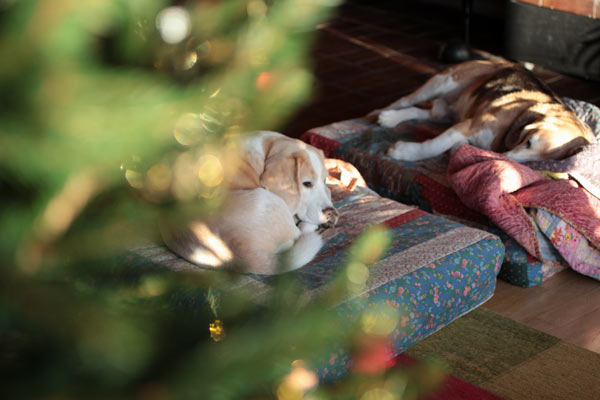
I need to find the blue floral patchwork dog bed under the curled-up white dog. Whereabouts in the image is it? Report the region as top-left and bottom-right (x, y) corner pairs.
(129, 176), (504, 380)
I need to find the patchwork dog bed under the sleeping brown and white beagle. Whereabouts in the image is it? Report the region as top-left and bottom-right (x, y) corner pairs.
(302, 99), (600, 287)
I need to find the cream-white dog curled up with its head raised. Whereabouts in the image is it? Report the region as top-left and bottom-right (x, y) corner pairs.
(161, 131), (337, 274)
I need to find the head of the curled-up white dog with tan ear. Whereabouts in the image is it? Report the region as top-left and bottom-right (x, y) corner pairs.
(260, 135), (338, 227)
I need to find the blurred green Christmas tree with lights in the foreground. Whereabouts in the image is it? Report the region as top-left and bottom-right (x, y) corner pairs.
(0, 0), (439, 399)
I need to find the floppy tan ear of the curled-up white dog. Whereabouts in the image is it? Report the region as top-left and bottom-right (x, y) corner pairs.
(260, 151), (310, 213)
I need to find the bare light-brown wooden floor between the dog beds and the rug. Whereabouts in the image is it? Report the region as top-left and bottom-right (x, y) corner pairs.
(483, 270), (600, 353)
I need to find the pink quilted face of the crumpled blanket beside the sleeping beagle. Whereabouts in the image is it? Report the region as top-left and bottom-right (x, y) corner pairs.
(448, 145), (600, 259)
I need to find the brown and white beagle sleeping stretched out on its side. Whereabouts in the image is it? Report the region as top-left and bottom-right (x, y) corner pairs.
(379, 60), (596, 162)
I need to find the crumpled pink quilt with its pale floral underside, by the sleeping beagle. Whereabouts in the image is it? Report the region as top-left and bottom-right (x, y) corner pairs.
(448, 145), (600, 277)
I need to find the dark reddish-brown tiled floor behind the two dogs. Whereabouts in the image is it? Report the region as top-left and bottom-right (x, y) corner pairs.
(282, 0), (600, 137)
